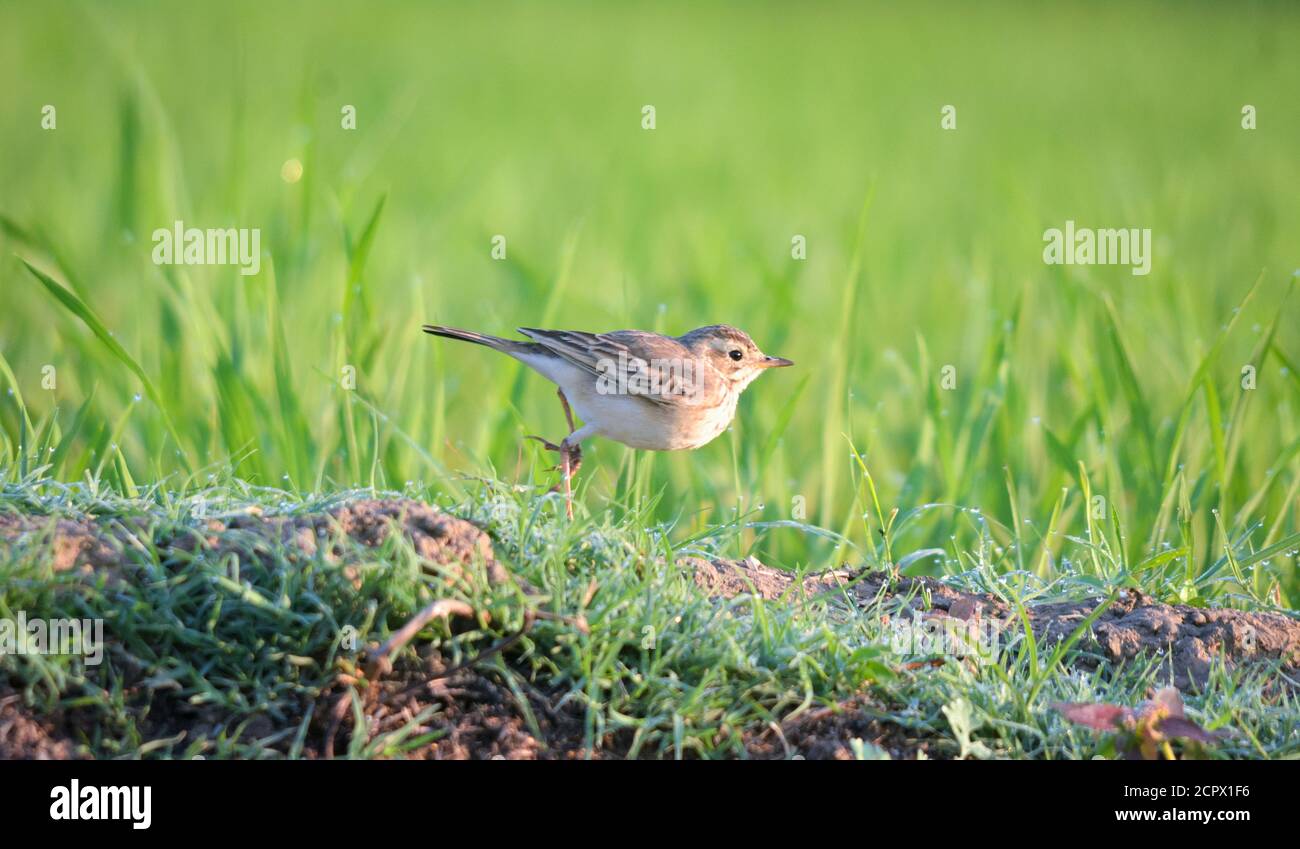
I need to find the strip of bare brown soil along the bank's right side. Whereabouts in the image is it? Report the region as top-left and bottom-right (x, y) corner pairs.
(681, 558), (1300, 690)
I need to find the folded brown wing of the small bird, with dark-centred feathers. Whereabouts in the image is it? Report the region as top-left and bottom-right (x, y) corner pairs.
(519, 328), (720, 406)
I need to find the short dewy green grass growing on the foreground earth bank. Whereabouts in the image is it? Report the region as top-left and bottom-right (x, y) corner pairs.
(0, 470), (1300, 758)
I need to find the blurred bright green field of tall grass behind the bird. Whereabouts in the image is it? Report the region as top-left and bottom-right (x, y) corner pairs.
(0, 1), (1300, 595)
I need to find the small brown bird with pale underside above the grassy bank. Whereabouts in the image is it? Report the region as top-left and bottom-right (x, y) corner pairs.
(423, 324), (794, 519)
